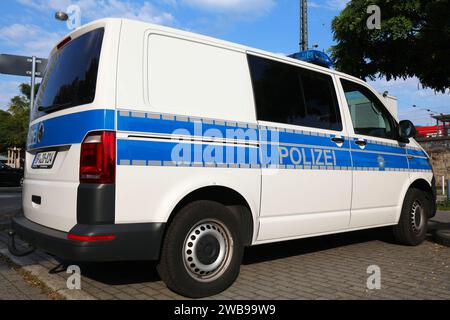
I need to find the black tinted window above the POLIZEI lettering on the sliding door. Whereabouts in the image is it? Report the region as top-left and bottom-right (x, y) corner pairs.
(248, 56), (342, 130)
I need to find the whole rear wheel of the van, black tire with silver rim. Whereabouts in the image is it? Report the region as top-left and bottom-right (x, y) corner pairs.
(157, 200), (244, 298)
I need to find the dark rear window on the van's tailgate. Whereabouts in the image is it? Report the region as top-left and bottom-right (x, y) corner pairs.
(31, 28), (104, 120)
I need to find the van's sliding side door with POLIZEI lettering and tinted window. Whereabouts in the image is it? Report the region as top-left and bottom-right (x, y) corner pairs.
(249, 55), (352, 241)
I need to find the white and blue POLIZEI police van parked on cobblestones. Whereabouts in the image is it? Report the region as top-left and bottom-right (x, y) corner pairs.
(12, 19), (436, 297)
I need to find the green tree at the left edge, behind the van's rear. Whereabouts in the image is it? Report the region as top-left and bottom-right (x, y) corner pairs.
(0, 83), (39, 152)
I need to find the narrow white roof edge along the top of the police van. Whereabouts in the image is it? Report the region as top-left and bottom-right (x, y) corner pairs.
(57, 18), (366, 83)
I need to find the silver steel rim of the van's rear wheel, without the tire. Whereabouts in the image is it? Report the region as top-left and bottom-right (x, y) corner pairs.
(183, 220), (233, 282)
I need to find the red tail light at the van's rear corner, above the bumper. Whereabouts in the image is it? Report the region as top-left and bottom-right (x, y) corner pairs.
(80, 131), (116, 184)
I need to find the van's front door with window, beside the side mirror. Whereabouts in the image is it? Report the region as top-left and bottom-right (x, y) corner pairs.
(340, 79), (409, 228)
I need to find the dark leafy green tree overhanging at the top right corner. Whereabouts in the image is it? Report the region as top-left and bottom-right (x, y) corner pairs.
(331, 0), (450, 92)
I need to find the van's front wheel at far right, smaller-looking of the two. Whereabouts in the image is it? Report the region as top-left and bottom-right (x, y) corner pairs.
(393, 188), (431, 246)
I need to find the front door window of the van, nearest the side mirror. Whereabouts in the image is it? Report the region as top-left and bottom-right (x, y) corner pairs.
(341, 79), (398, 139)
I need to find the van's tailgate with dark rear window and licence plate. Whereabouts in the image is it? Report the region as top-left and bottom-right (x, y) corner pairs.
(23, 26), (114, 231)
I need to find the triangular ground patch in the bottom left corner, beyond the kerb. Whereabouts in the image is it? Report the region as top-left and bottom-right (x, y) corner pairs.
(0, 257), (49, 300)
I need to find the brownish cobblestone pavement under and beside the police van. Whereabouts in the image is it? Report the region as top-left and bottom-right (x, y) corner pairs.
(0, 212), (450, 299)
